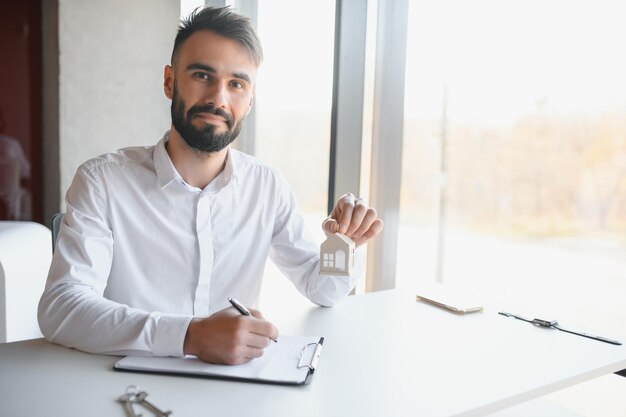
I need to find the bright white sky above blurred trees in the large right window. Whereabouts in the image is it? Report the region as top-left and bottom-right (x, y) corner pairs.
(406, 0), (626, 123)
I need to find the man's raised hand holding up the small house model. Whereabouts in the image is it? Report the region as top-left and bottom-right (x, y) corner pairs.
(322, 193), (383, 246)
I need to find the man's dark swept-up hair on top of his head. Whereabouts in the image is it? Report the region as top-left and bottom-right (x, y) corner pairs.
(172, 6), (263, 67)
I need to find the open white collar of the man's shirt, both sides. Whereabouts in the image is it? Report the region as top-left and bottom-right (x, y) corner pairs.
(154, 130), (241, 192)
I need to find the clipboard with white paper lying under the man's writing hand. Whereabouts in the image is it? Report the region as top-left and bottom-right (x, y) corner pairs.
(113, 336), (324, 385)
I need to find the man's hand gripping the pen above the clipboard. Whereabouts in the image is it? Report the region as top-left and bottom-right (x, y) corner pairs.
(183, 307), (278, 365)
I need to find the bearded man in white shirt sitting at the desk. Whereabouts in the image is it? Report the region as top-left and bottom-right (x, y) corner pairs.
(39, 8), (383, 364)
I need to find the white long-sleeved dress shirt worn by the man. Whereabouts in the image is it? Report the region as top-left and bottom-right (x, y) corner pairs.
(39, 133), (364, 356)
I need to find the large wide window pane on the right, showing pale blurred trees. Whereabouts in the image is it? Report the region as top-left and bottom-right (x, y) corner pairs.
(398, 0), (626, 318)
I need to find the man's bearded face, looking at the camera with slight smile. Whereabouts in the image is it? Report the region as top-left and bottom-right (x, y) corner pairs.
(165, 31), (256, 152)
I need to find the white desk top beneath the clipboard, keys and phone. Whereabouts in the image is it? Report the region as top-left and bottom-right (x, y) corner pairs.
(0, 291), (626, 417)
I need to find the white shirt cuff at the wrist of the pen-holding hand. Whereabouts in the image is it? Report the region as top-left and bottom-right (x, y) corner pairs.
(152, 314), (192, 357)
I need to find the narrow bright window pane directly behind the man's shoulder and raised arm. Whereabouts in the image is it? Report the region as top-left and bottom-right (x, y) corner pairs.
(255, 0), (335, 302)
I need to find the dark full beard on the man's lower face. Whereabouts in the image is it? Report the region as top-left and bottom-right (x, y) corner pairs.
(171, 84), (244, 153)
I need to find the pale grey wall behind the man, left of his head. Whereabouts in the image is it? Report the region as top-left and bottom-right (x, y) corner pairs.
(58, 0), (180, 205)
